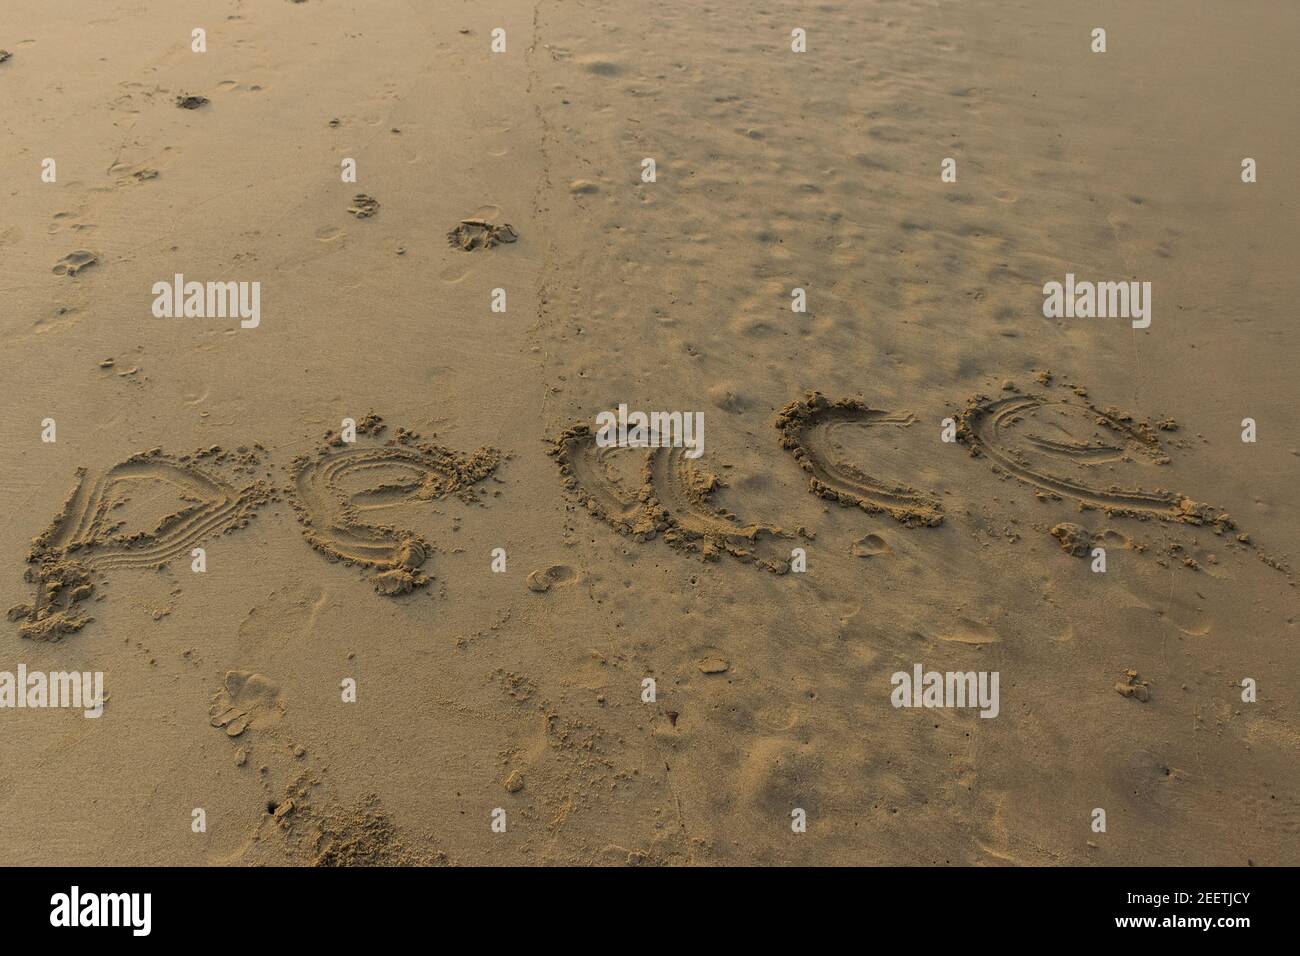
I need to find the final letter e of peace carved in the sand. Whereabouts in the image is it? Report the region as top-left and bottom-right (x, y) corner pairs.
(957, 389), (1232, 531)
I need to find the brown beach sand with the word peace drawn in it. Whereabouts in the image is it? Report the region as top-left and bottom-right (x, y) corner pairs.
(0, 0), (1300, 865)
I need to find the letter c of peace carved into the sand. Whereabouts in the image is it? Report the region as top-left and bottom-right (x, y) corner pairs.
(776, 392), (944, 527)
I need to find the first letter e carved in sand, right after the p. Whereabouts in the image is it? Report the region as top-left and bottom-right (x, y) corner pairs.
(293, 415), (501, 596)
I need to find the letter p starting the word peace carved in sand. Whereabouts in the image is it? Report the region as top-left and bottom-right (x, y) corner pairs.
(9, 446), (272, 640)
